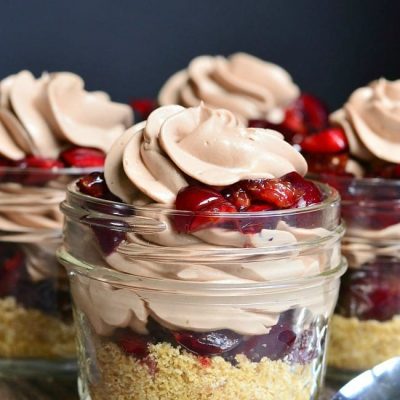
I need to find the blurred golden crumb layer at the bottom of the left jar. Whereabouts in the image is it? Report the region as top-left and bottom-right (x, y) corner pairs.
(0, 297), (76, 359)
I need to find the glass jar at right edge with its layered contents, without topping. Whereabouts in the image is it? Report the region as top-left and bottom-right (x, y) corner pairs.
(314, 176), (400, 379)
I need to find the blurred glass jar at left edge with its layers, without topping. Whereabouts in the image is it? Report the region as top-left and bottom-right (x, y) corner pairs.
(0, 167), (98, 375)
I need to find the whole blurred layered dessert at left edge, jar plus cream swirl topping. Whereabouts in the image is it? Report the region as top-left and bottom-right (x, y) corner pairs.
(0, 71), (132, 373)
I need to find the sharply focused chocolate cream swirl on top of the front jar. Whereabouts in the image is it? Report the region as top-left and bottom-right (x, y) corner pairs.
(105, 104), (307, 204)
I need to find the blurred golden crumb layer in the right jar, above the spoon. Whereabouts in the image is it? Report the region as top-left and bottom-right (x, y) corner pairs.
(328, 315), (400, 371)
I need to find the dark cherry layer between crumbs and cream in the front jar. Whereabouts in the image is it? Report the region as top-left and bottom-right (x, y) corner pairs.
(113, 310), (324, 367)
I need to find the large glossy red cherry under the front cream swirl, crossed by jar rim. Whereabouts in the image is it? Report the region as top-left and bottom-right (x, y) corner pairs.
(174, 186), (237, 232)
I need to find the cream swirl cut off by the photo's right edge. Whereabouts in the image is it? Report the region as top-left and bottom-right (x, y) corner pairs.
(330, 78), (400, 163)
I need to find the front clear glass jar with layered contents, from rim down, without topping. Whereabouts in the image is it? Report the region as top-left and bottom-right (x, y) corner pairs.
(58, 185), (346, 400)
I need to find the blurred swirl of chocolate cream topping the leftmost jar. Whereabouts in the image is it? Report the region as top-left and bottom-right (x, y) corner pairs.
(0, 71), (133, 160)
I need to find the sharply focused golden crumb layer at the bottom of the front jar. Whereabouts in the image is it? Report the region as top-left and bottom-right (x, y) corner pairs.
(89, 342), (314, 400)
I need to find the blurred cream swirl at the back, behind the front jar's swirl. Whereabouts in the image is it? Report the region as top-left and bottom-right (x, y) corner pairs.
(158, 53), (300, 123)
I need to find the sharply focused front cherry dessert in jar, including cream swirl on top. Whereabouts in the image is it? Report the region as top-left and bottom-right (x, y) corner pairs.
(58, 105), (345, 400)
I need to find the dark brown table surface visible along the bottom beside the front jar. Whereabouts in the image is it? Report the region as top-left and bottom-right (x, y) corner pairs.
(0, 377), (334, 400)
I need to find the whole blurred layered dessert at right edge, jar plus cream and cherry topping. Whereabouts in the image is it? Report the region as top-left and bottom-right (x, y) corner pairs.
(284, 78), (400, 377)
